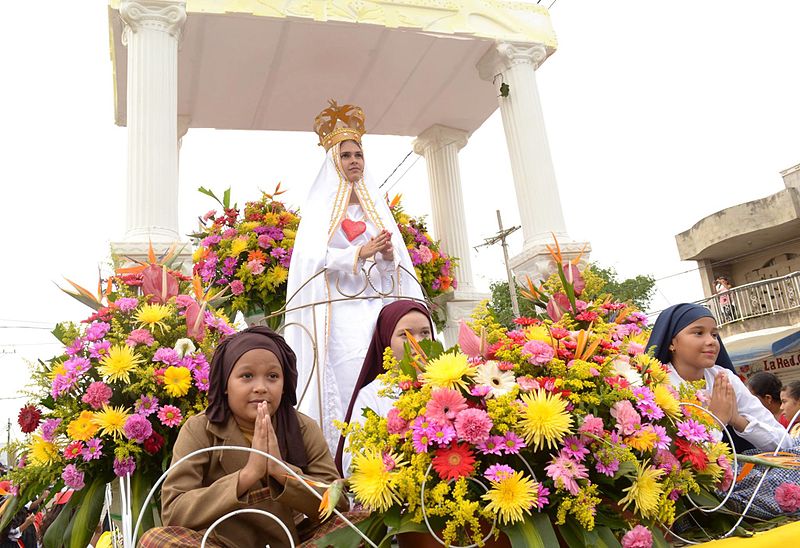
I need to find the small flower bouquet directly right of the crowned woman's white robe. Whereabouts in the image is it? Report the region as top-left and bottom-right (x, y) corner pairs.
(389, 195), (458, 329)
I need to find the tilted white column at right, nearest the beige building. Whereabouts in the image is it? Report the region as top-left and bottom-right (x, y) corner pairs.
(478, 42), (589, 278)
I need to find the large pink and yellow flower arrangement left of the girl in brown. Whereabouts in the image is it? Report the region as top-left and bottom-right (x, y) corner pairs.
(0, 249), (233, 546)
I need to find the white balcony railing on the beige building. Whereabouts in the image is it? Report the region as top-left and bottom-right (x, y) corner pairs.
(697, 272), (800, 326)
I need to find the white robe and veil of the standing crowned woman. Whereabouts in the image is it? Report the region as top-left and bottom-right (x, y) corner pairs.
(284, 144), (423, 452)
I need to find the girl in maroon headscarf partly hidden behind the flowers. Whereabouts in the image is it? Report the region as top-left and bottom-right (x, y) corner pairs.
(336, 299), (434, 473)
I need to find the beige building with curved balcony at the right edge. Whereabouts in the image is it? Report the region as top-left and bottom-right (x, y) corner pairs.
(675, 164), (800, 382)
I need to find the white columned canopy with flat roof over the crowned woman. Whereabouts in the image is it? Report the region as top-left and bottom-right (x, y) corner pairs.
(109, 0), (584, 338)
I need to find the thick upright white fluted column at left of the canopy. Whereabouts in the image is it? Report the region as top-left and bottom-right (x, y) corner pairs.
(119, 0), (186, 243)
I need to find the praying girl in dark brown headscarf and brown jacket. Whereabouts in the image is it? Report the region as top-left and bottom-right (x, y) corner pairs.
(139, 327), (339, 548)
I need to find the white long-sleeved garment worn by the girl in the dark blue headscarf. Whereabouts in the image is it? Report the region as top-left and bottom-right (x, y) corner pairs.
(667, 364), (792, 451)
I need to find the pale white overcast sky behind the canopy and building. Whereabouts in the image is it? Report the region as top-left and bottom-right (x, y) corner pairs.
(0, 0), (800, 438)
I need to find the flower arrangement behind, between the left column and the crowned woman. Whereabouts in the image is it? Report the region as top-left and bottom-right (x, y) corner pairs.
(193, 185), (300, 327)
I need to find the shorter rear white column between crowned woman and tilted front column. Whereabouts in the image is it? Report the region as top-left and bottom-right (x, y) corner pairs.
(413, 125), (475, 292)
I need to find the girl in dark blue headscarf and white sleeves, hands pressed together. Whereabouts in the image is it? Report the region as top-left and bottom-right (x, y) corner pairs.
(647, 303), (788, 452)
